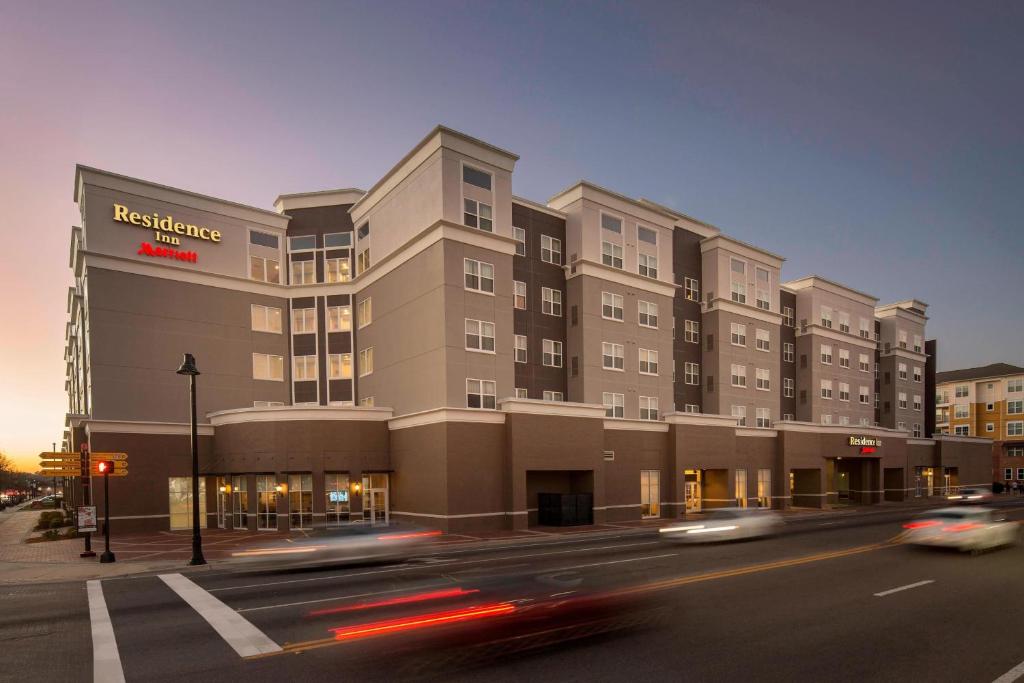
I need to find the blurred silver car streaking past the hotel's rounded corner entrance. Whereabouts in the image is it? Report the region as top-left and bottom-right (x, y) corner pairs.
(231, 524), (441, 566)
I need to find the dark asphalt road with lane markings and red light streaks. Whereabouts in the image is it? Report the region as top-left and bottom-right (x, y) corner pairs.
(6, 500), (1024, 682)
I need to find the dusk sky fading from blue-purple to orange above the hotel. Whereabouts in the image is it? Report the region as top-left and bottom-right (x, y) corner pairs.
(0, 0), (1024, 468)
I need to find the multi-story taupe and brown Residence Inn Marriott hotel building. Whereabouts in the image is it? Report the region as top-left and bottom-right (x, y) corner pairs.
(65, 127), (990, 531)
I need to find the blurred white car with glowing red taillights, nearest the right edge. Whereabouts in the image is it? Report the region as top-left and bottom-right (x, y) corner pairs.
(903, 508), (1020, 552)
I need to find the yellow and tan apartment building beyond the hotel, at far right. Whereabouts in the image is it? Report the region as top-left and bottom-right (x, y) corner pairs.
(935, 362), (1024, 483)
